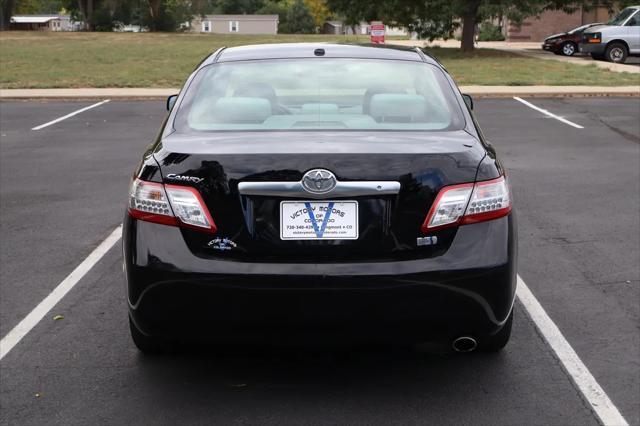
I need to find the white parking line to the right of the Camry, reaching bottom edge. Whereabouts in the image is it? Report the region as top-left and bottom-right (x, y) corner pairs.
(516, 275), (629, 426)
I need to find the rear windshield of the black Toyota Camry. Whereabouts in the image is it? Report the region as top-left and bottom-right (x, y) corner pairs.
(175, 58), (464, 131)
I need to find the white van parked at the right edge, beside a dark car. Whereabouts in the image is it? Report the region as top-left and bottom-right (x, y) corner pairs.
(580, 6), (640, 63)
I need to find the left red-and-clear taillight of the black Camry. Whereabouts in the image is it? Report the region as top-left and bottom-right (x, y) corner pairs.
(129, 179), (217, 233)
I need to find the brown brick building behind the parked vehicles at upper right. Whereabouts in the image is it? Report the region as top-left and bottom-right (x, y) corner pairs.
(505, 7), (611, 42)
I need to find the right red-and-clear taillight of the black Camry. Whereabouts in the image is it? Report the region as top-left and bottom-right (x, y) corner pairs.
(422, 176), (511, 233)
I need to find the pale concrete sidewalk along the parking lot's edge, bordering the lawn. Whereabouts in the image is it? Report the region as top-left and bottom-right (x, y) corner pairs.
(0, 85), (640, 99)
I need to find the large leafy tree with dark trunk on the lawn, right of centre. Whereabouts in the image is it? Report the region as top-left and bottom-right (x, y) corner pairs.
(328, 0), (616, 52)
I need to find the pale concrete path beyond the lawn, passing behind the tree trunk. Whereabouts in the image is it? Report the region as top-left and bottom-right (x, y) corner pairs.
(387, 40), (640, 74)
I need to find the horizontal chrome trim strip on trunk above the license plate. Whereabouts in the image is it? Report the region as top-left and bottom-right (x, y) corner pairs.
(238, 181), (400, 199)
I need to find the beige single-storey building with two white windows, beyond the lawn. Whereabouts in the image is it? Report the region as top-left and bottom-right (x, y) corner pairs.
(191, 15), (278, 34)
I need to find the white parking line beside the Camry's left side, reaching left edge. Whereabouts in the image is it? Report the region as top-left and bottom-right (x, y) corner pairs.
(0, 225), (122, 360)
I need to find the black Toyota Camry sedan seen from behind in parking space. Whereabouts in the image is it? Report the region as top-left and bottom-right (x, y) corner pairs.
(123, 44), (516, 352)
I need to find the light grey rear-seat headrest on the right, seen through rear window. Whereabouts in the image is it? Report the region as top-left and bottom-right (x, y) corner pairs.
(369, 93), (427, 123)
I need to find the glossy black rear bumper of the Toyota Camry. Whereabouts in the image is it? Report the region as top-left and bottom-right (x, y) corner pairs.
(123, 215), (516, 341)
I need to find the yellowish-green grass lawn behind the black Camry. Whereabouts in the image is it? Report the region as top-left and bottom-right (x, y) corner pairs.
(0, 32), (640, 89)
